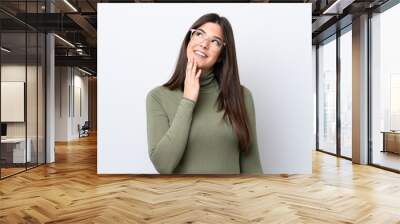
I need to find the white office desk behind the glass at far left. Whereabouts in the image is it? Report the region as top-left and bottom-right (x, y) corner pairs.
(1, 138), (32, 163)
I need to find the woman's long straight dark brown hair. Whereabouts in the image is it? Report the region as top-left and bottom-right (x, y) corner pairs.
(163, 13), (250, 152)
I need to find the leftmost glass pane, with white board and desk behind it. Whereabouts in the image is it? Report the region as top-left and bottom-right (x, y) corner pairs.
(0, 32), (27, 177)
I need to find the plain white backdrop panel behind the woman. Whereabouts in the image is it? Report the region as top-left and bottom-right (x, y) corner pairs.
(97, 3), (314, 174)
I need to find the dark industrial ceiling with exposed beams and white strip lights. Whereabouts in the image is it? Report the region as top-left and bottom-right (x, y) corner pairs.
(0, 0), (394, 73)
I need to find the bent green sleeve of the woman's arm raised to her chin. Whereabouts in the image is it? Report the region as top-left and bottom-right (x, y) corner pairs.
(146, 91), (195, 174)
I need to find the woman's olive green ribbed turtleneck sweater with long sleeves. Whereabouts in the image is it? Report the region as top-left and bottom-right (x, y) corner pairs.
(146, 72), (262, 174)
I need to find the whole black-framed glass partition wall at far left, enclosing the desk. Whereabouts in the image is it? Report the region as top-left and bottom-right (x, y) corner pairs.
(0, 1), (46, 179)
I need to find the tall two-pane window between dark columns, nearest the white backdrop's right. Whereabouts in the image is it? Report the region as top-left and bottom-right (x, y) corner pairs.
(316, 25), (352, 159)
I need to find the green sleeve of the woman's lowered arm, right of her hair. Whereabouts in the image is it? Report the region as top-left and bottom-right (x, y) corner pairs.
(240, 88), (263, 174)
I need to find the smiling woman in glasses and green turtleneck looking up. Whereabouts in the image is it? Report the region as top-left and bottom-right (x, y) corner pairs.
(146, 13), (262, 174)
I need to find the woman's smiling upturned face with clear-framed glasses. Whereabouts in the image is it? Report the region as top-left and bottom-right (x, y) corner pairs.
(186, 22), (224, 72)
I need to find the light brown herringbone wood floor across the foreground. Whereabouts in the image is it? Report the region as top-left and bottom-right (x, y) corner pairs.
(0, 134), (400, 224)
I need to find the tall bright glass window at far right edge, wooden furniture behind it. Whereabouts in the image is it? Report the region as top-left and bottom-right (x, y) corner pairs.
(370, 4), (400, 171)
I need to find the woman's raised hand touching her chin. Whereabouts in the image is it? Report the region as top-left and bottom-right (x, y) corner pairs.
(183, 58), (201, 102)
